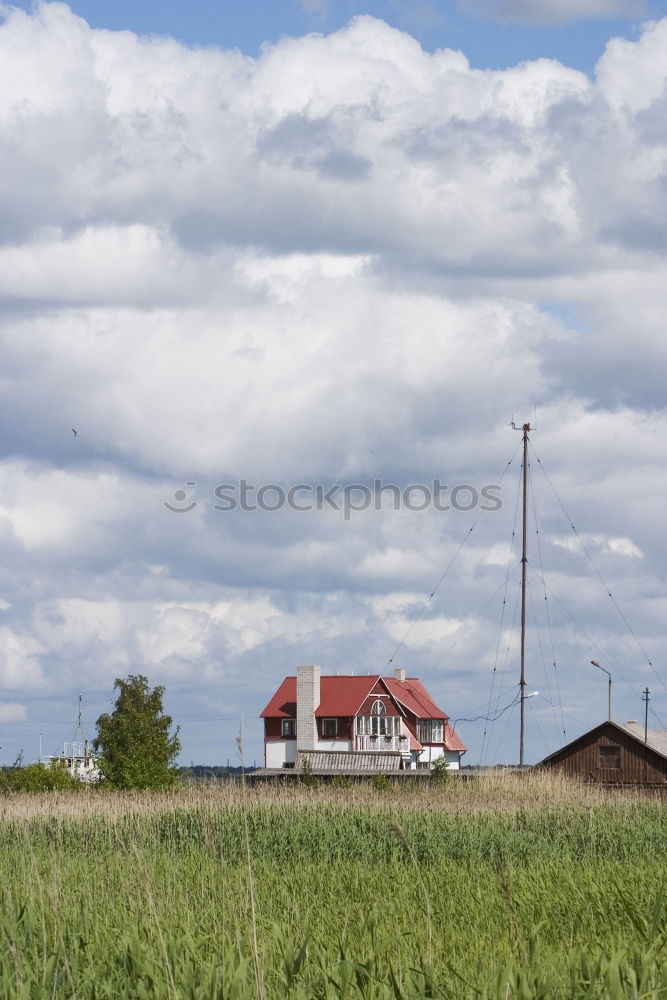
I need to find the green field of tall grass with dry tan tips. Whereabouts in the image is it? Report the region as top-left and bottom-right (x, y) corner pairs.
(0, 775), (667, 1000)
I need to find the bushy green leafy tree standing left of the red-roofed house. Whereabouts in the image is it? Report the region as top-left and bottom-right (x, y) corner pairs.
(94, 674), (181, 788)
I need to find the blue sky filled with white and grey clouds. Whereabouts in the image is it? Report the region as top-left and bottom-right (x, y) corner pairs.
(0, 0), (667, 764)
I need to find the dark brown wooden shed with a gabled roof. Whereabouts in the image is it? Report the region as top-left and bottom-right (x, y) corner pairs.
(536, 722), (667, 785)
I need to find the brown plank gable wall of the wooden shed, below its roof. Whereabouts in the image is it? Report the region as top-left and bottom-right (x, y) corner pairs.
(542, 724), (667, 784)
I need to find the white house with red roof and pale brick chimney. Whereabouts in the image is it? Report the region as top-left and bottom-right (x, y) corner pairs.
(261, 665), (466, 774)
